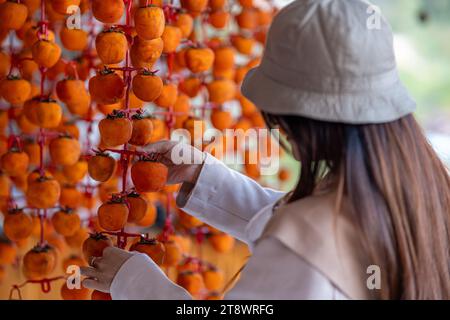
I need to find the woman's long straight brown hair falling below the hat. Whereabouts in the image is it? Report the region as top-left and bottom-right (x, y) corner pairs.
(264, 114), (450, 299)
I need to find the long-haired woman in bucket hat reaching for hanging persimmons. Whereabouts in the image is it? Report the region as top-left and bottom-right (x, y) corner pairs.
(83, 0), (450, 299)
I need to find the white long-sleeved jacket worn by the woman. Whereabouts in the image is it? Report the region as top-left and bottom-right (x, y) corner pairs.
(111, 156), (365, 299)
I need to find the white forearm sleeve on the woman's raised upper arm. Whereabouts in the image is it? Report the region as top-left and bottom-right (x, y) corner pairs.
(177, 155), (284, 242)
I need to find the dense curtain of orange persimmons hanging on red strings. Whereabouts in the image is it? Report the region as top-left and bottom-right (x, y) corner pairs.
(0, 0), (287, 299)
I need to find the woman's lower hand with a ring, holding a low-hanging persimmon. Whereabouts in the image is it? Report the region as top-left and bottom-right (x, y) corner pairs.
(81, 247), (133, 293)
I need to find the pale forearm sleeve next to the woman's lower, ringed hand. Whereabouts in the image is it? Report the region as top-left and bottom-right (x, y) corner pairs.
(110, 253), (192, 300)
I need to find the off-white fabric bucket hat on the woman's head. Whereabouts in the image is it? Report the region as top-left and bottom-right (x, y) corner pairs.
(242, 0), (416, 124)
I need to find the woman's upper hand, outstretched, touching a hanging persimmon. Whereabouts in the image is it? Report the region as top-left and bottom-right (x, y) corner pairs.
(145, 140), (204, 184)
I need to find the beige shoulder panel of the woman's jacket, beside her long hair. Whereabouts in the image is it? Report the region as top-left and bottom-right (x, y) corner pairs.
(258, 192), (369, 299)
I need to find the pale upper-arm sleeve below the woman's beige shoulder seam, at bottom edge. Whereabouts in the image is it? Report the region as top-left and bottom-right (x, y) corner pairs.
(225, 238), (347, 300)
